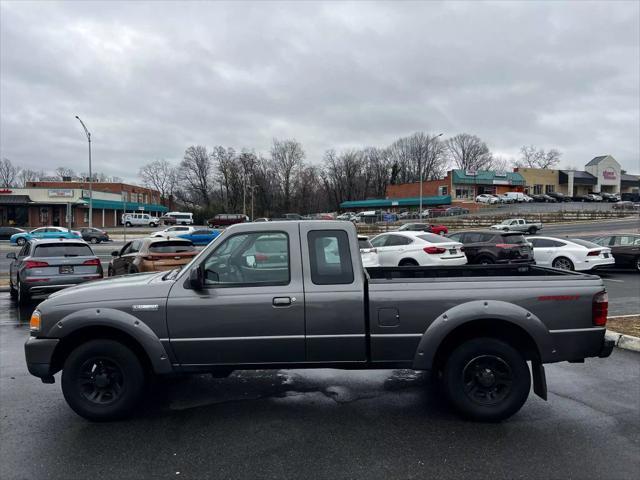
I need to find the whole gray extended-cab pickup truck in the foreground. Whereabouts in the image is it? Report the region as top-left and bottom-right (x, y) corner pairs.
(25, 221), (613, 421)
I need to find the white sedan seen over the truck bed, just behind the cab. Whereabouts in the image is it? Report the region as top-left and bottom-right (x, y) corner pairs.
(371, 231), (467, 267)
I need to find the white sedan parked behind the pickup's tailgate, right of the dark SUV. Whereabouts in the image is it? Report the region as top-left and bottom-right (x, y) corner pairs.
(527, 237), (615, 272)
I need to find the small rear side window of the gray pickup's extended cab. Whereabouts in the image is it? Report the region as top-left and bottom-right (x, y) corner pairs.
(307, 230), (354, 285)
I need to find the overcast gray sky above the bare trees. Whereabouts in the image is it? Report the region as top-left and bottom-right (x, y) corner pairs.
(0, 0), (640, 179)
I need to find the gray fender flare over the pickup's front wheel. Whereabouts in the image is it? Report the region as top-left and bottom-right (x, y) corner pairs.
(47, 307), (173, 374)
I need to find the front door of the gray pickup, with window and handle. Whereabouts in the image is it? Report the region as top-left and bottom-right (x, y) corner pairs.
(167, 223), (305, 366)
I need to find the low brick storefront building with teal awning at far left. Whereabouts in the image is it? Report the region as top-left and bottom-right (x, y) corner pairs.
(0, 182), (168, 228)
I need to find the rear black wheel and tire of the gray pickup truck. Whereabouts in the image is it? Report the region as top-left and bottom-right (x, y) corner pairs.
(443, 338), (531, 422)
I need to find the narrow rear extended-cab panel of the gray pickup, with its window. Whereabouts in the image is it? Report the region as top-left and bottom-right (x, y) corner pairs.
(300, 222), (367, 363)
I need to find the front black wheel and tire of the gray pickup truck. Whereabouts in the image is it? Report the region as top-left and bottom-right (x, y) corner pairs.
(62, 340), (145, 421)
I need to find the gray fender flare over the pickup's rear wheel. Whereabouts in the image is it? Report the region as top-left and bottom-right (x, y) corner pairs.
(413, 300), (551, 370)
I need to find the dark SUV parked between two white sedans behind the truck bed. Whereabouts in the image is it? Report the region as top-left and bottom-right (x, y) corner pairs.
(448, 230), (535, 265)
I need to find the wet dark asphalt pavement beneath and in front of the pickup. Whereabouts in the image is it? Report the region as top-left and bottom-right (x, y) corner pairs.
(0, 295), (640, 480)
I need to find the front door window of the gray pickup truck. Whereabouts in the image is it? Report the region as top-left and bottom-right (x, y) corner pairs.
(203, 232), (290, 287)
